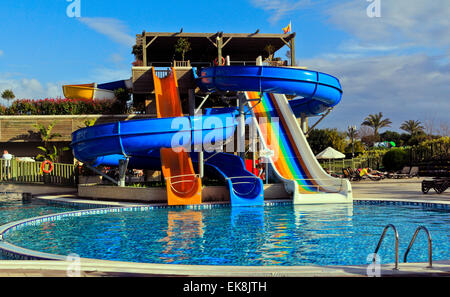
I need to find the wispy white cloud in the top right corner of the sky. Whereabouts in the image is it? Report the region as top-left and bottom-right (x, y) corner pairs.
(326, 0), (450, 47)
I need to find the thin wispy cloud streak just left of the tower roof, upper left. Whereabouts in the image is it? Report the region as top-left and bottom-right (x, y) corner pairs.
(78, 17), (136, 47)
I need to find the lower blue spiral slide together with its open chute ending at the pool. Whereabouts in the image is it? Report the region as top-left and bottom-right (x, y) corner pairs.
(71, 109), (264, 206)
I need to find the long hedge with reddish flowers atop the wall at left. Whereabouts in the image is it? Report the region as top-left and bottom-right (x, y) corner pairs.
(0, 98), (123, 115)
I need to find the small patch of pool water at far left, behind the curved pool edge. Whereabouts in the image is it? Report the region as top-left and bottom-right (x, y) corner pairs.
(0, 200), (79, 260)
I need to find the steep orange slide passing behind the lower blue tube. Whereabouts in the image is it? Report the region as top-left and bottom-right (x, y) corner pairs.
(152, 68), (202, 205)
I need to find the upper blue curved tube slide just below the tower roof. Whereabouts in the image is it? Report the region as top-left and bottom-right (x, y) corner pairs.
(194, 66), (342, 117)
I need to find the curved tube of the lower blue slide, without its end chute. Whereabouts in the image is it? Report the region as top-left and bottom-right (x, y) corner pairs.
(71, 113), (236, 165)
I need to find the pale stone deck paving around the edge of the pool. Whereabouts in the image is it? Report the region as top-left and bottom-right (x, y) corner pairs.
(0, 178), (450, 277)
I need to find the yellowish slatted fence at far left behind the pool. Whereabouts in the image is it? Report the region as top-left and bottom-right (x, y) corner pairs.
(0, 159), (77, 185)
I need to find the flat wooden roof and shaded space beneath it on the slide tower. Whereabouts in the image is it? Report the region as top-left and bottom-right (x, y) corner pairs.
(137, 32), (295, 66)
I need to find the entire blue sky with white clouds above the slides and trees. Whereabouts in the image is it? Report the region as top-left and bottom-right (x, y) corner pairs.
(0, 0), (450, 134)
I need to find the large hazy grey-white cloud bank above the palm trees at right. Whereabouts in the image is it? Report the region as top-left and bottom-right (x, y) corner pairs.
(302, 54), (450, 130)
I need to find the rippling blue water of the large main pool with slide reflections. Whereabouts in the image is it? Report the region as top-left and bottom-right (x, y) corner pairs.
(2, 204), (450, 266)
